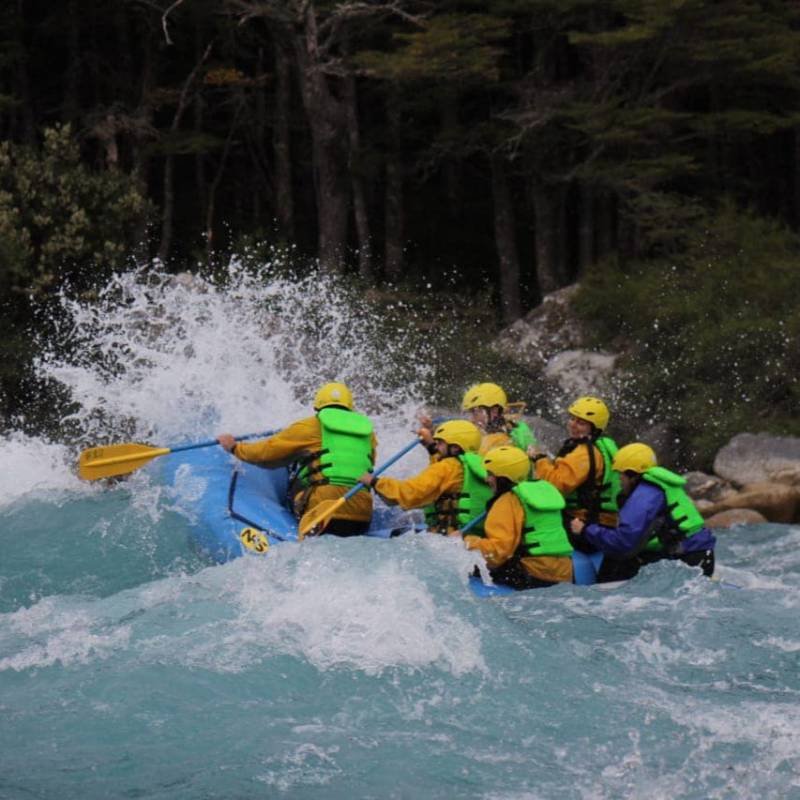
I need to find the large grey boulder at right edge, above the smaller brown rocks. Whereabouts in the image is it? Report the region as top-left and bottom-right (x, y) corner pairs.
(714, 433), (800, 486)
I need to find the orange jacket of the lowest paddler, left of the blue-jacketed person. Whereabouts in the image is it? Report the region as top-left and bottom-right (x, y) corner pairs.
(464, 492), (572, 583)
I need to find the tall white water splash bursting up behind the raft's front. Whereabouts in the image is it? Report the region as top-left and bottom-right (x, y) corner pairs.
(35, 259), (438, 454)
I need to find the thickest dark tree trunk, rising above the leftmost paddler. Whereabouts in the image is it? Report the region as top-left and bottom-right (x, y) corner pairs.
(295, 3), (350, 270)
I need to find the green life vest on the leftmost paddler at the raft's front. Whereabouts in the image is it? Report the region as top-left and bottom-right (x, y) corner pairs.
(299, 407), (373, 486)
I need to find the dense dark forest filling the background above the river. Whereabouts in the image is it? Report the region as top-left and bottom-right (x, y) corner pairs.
(0, 0), (800, 460)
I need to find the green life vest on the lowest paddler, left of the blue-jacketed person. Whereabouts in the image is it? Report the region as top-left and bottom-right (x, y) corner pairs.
(511, 481), (572, 558)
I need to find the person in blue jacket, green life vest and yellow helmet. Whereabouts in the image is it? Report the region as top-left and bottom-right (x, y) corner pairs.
(570, 442), (716, 577)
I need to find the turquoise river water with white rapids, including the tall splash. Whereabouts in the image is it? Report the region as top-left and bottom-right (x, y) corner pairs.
(0, 262), (800, 800)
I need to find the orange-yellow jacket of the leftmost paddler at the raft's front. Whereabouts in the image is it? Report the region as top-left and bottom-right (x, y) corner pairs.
(233, 416), (378, 522)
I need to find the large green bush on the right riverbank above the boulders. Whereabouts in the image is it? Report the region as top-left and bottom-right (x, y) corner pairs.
(577, 203), (800, 465)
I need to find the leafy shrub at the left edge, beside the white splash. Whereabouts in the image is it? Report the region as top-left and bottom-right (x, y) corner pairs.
(0, 125), (152, 427)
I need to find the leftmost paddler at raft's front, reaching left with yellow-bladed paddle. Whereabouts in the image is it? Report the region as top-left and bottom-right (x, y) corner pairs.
(217, 382), (377, 536)
